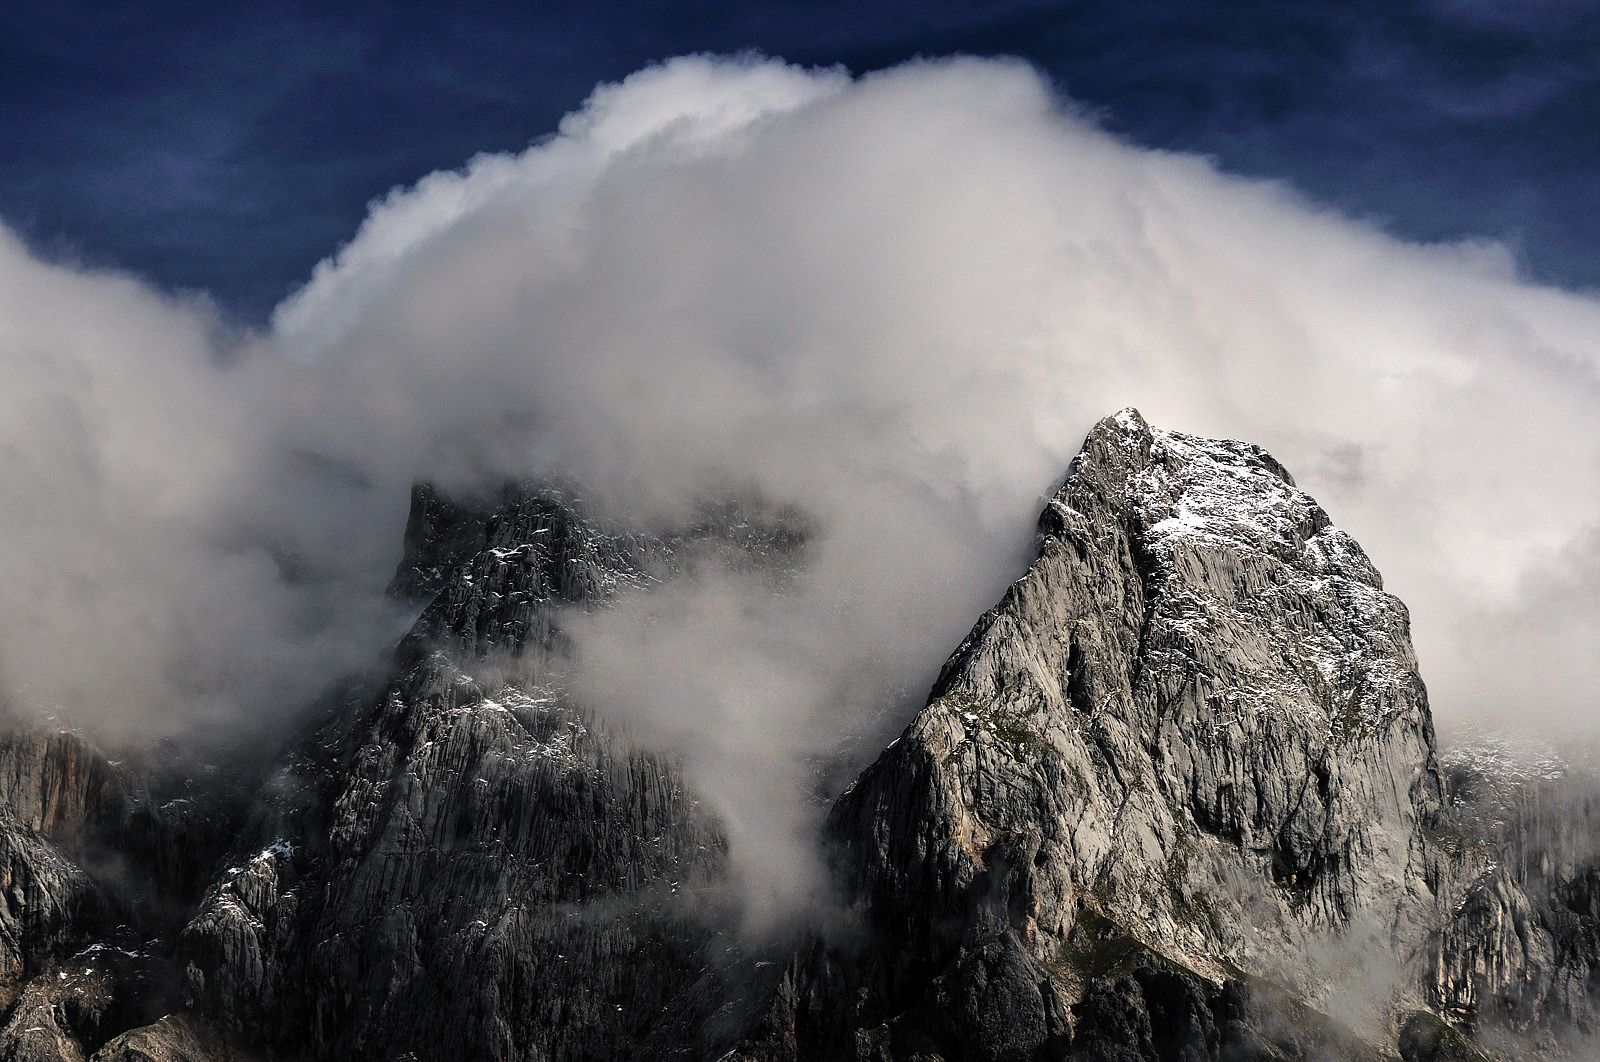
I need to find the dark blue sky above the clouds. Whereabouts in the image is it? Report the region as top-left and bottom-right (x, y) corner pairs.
(0, 0), (1600, 321)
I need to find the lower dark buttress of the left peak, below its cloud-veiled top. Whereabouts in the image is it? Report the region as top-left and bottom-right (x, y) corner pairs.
(182, 661), (722, 1059)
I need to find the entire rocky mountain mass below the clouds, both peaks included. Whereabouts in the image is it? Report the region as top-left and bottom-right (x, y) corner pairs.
(0, 409), (1600, 1062)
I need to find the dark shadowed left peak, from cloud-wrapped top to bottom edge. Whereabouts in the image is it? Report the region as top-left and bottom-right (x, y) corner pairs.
(170, 488), (800, 1059)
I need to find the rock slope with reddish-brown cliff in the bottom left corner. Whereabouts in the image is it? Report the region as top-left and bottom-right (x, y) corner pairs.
(0, 720), (242, 1060)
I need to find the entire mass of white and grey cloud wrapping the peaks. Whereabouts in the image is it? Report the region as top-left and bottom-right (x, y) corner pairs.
(0, 58), (1600, 889)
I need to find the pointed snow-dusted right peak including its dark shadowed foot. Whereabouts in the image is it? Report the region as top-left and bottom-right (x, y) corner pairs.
(746, 409), (1440, 1059)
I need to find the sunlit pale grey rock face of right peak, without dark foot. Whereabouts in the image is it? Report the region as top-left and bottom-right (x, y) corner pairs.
(834, 411), (1440, 953)
